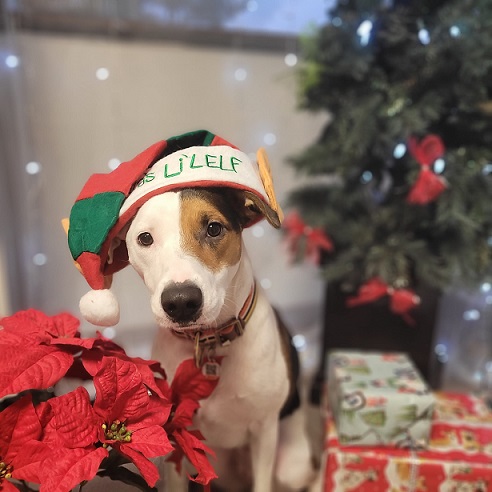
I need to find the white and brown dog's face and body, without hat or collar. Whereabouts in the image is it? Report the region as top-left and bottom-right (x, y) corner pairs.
(125, 188), (312, 492)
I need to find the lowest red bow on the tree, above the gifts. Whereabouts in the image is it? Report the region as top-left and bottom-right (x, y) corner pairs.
(347, 277), (420, 325)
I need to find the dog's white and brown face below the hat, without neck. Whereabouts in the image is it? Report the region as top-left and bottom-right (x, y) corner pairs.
(125, 188), (260, 330)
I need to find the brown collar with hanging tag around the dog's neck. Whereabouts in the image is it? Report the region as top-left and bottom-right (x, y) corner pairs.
(173, 282), (258, 367)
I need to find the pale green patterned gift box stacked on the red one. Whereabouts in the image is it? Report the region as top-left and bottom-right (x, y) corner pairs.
(328, 350), (434, 446)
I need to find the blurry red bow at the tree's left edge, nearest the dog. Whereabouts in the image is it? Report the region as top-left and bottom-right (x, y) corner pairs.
(283, 211), (333, 264)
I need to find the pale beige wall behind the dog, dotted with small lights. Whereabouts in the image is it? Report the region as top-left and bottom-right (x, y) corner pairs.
(3, 29), (324, 338)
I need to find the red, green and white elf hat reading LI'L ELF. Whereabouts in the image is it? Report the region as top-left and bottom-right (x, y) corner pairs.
(68, 130), (282, 326)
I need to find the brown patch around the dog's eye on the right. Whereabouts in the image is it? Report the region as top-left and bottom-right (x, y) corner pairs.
(180, 188), (242, 272)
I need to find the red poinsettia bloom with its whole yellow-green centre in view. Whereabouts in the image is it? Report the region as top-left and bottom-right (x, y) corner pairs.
(94, 357), (173, 487)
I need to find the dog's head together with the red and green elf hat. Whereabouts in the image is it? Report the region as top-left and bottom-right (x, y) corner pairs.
(68, 130), (282, 328)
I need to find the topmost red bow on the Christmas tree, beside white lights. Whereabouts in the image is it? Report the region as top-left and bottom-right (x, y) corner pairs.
(407, 135), (447, 205)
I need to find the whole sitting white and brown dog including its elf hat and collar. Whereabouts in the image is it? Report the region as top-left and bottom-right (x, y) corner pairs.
(68, 130), (312, 492)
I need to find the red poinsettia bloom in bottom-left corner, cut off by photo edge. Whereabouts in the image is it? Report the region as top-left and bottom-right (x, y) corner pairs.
(0, 396), (43, 492)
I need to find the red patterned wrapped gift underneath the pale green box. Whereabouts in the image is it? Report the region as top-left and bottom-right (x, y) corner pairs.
(324, 393), (492, 492)
